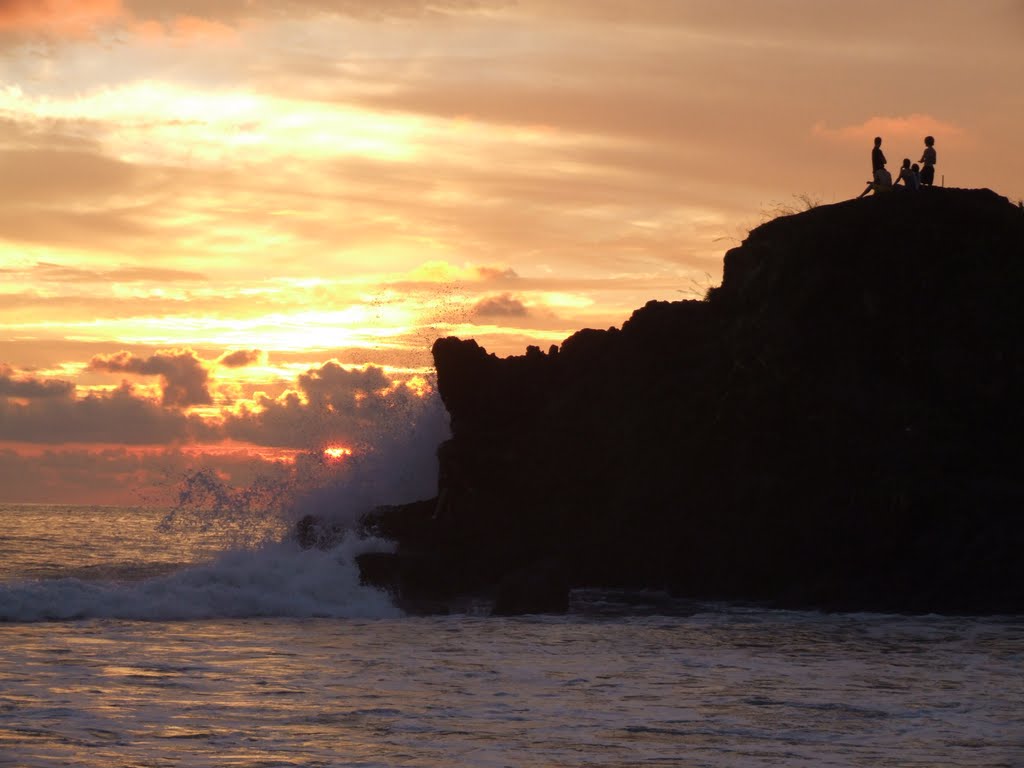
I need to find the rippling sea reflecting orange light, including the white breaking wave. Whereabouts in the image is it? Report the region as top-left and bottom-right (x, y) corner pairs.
(0, 505), (1024, 768)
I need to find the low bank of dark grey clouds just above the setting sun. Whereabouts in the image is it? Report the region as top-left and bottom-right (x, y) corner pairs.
(0, 358), (436, 450)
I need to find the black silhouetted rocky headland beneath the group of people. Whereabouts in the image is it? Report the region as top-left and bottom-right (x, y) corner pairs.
(358, 188), (1024, 611)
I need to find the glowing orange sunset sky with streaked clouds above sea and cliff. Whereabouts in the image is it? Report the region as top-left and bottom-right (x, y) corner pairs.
(0, 0), (1024, 504)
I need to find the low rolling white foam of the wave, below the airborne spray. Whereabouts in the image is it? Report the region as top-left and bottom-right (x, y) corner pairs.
(0, 536), (401, 622)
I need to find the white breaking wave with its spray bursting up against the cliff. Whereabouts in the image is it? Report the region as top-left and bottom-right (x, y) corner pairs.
(0, 393), (449, 622)
